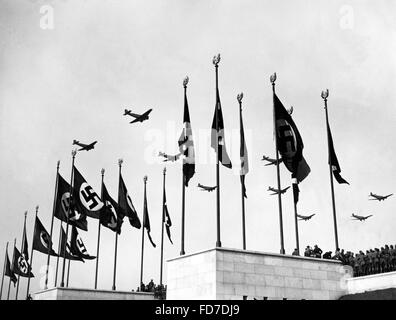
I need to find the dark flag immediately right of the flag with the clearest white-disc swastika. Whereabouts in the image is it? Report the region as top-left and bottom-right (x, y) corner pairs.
(100, 183), (124, 234)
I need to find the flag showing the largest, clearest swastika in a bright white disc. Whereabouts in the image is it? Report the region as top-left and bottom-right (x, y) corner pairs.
(73, 167), (103, 219)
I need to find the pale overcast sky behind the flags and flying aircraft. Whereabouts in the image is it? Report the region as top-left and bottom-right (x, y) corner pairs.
(0, 0), (396, 298)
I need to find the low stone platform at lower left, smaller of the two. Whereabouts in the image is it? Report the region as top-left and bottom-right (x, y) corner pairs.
(33, 287), (154, 300)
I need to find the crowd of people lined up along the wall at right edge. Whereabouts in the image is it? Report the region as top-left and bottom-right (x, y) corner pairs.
(293, 245), (396, 277)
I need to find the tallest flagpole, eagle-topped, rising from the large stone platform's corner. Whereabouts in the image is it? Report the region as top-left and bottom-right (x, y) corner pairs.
(213, 54), (221, 248)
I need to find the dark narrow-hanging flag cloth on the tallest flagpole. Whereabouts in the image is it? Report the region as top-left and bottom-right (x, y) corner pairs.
(211, 89), (232, 169)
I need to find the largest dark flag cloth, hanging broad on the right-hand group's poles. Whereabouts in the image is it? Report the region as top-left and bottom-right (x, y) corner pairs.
(274, 93), (311, 182)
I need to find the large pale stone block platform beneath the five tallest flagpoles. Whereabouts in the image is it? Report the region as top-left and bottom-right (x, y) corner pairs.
(167, 248), (353, 300)
